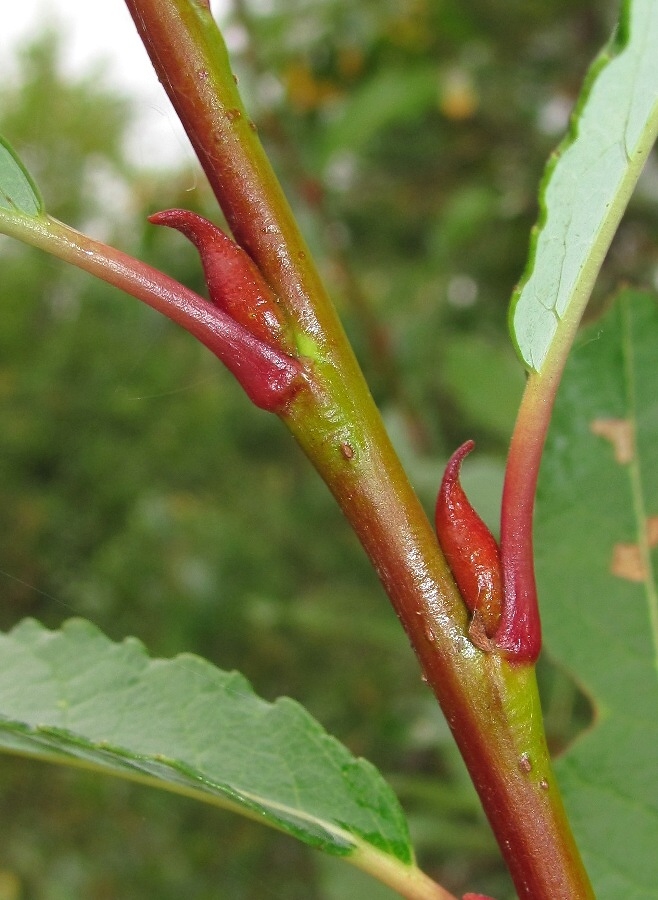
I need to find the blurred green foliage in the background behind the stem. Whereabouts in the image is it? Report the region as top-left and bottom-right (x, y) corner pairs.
(0, 0), (658, 900)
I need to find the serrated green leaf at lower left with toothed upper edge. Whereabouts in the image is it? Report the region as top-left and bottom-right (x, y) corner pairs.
(0, 619), (413, 871)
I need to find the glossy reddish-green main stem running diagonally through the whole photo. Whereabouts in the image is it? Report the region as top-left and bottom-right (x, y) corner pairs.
(120, 0), (593, 900)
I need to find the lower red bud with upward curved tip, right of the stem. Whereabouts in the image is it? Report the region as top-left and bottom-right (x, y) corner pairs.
(435, 441), (503, 650)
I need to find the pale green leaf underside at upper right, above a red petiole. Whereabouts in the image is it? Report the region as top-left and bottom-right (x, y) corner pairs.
(510, 0), (658, 372)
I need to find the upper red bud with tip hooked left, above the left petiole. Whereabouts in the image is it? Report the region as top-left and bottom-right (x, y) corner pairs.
(149, 209), (286, 349)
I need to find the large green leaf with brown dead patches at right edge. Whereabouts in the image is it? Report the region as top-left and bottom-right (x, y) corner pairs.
(536, 291), (658, 900)
